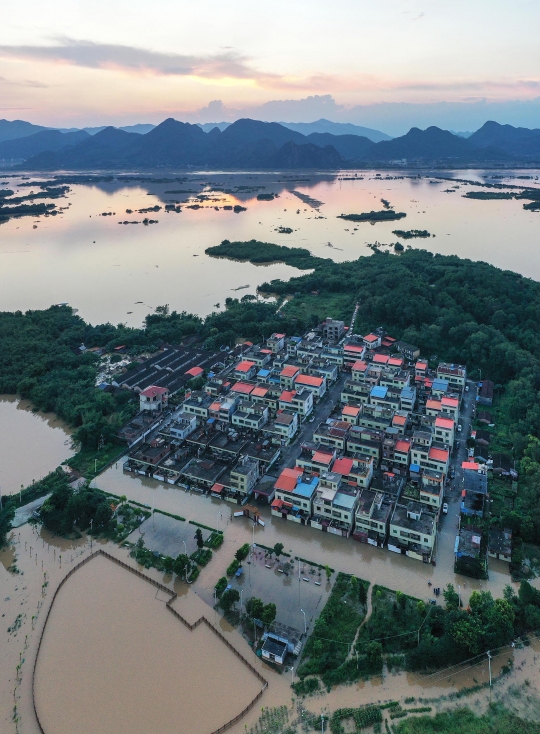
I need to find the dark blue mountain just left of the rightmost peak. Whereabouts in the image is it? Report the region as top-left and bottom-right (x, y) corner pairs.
(363, 127), (507, 163)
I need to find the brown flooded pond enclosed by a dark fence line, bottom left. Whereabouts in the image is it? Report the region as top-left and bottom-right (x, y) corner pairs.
(34, 557), (262, 734)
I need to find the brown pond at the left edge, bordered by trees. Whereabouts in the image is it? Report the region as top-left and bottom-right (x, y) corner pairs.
(0, 395), (73, 495)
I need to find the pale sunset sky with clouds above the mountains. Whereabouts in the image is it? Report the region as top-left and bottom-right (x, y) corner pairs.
(0, 0), (540, 134)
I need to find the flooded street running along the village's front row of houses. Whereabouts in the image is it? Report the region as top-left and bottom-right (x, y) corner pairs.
(94, 462), (528, 608)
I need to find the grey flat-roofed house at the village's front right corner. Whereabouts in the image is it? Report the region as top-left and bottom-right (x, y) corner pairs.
(388, 498), (437, 563)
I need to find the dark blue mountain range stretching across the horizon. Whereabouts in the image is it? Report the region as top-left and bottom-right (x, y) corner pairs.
(0, 118), (540, 171)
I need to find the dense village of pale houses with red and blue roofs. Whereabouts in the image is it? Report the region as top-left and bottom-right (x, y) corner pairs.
(113, 317), (512, 578)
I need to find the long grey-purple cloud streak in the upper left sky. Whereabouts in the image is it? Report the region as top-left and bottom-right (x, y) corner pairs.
(0, 37), (274, 81)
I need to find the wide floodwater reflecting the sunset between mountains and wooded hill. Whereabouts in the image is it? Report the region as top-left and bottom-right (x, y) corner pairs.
(0, 171), (540, 326)
